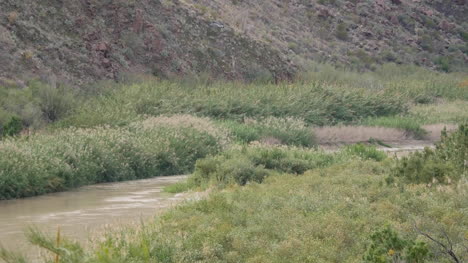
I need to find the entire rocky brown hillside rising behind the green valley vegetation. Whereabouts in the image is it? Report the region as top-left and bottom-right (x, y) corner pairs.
(0, 0), (468, 85)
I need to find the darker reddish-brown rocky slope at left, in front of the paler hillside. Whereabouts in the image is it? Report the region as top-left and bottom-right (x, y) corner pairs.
(0, 0), (295, 84)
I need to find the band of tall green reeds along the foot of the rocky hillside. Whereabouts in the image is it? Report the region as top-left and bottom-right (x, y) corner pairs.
(0, 64), (468, 138)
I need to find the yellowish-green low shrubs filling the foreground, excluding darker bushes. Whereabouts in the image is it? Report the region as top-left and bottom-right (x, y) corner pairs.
(11, 161), (468, 263)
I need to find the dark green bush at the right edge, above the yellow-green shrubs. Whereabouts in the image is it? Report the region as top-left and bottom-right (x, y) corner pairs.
(389, 125), (468, 183)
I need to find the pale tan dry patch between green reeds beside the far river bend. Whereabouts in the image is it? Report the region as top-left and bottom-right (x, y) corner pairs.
(314, 124), (457, 146)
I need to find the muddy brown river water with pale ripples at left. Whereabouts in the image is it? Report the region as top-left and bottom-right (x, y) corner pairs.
(0, 176), (185, 256)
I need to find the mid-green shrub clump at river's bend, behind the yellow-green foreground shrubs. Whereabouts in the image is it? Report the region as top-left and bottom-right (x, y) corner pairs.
(189, 145), (360, 187)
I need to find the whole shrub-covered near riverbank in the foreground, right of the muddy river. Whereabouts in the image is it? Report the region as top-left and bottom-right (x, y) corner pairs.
(3, 126), (468, 263)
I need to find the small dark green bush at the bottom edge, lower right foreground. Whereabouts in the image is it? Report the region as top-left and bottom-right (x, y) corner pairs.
(364, 226), (429, 263)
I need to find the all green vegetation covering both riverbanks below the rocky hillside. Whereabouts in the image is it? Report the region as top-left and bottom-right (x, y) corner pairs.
(0, 65), (468, 263)
